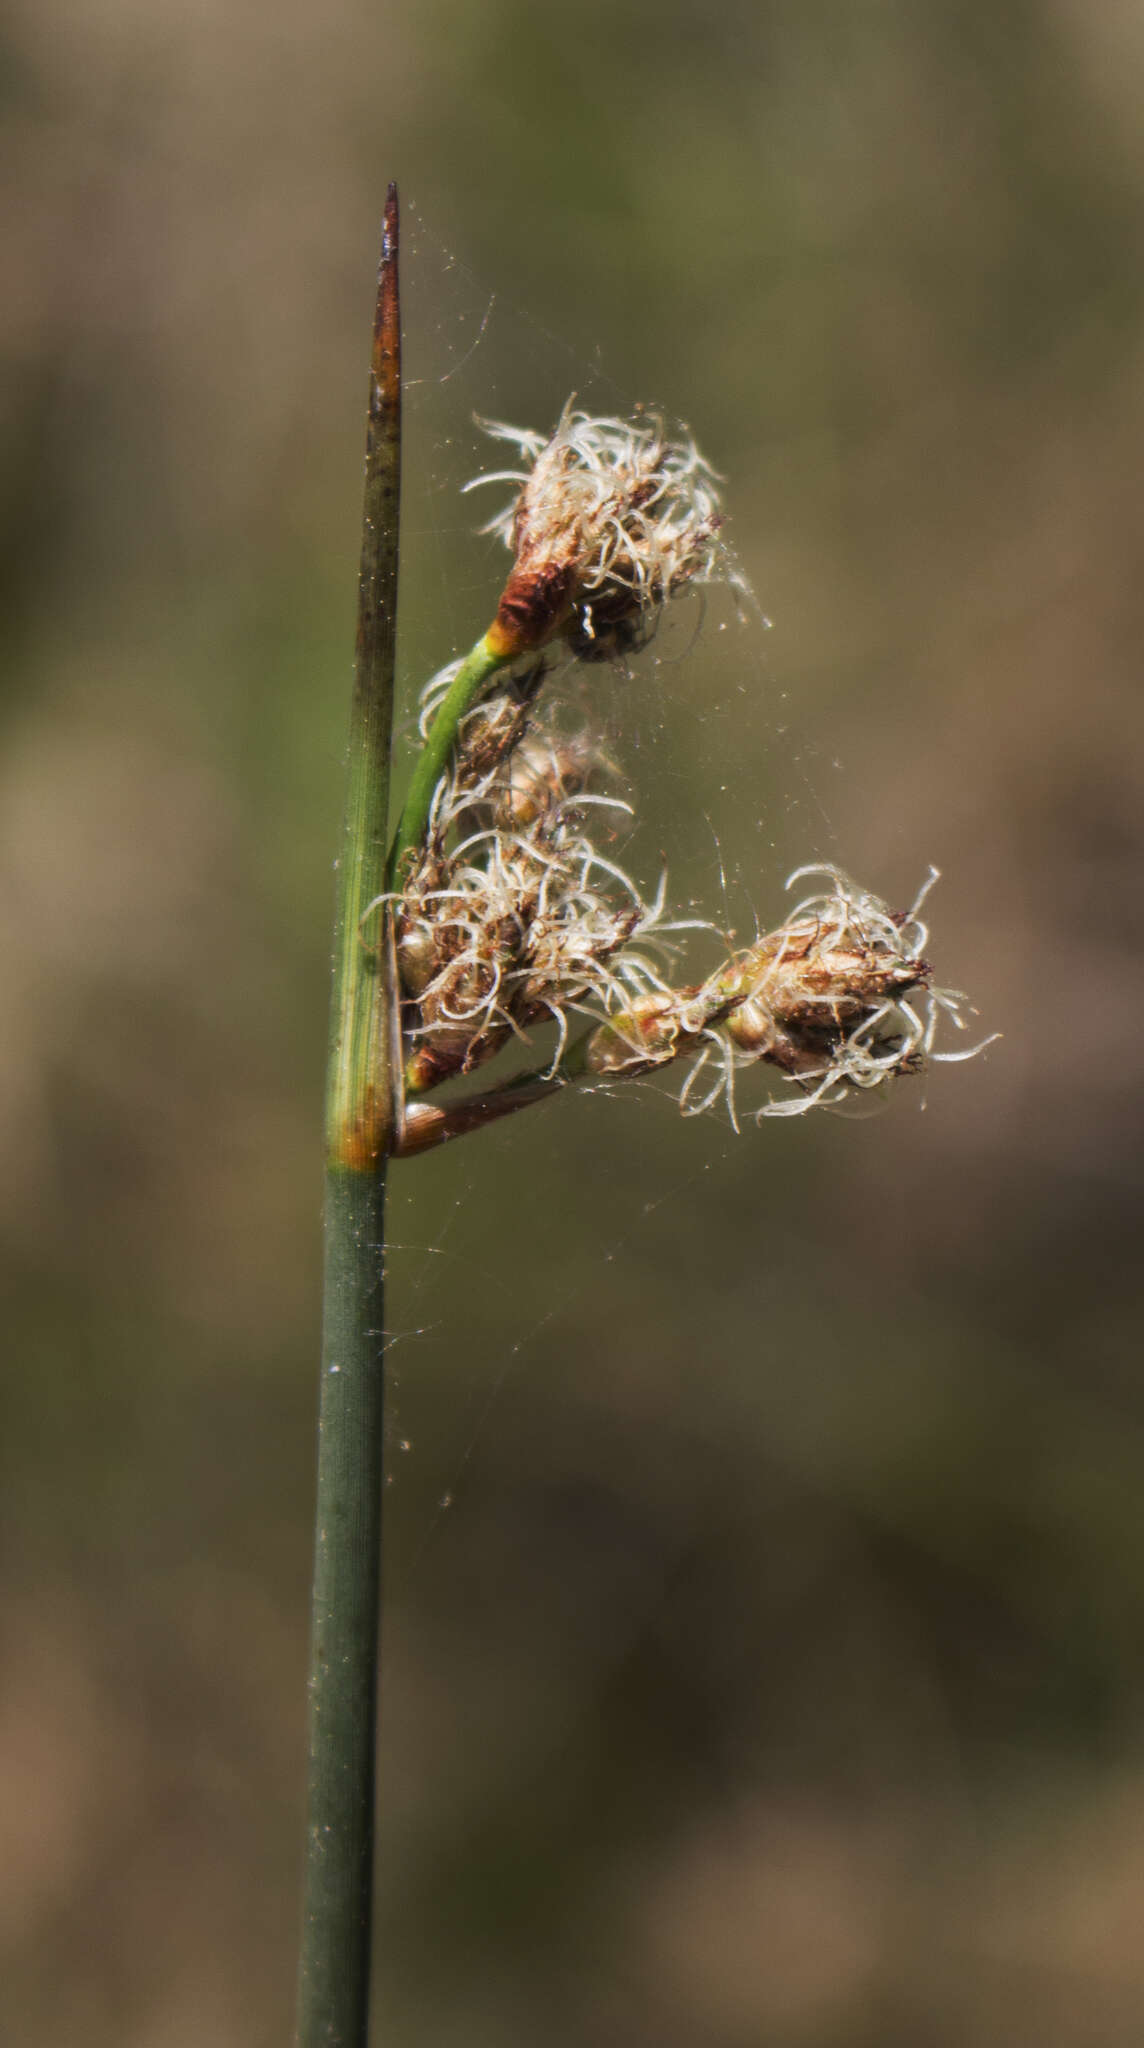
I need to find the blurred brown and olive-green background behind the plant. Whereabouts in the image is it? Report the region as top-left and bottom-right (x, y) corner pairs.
(0, 0), (1144, 2048)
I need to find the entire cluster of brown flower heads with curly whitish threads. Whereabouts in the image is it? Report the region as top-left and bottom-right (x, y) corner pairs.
(393, 408), (994, 1128)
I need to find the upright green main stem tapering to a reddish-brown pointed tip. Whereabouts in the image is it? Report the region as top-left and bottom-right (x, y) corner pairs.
(297, 186), (401, 2048)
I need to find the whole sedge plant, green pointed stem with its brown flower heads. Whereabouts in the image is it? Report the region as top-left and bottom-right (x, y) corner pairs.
(299, 188), (988, 2048)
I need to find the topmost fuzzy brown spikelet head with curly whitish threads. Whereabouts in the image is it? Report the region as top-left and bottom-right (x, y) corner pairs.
(467, 401), (747, 659)
